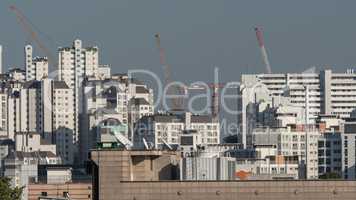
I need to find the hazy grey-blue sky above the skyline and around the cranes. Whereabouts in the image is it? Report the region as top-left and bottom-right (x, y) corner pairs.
(0, 0), (356, 81)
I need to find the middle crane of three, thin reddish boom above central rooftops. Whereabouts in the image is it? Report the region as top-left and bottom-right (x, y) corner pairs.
(155, 33), (184, 111)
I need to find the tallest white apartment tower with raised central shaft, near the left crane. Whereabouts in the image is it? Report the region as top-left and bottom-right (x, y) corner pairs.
(58, 39), (99, 150)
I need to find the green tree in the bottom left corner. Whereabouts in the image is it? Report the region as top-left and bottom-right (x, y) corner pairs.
(0, 177), (23, 200)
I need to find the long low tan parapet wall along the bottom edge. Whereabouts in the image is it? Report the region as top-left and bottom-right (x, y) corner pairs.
(118, 181), (356, 200)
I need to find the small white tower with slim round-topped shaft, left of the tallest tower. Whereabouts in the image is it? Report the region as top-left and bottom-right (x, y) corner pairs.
(25, 45), (48, 81)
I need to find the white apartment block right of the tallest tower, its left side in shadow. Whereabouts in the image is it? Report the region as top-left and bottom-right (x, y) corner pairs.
(80, 74), (153, 160)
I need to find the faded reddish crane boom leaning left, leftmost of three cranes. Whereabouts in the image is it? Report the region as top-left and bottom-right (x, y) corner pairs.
(9, 5), (56, 70)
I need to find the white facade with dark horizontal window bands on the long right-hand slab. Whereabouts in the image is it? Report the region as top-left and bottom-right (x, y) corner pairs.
(241, 70), (356, 122)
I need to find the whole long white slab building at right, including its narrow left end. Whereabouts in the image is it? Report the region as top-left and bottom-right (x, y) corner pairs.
(238, 70), (356, 148)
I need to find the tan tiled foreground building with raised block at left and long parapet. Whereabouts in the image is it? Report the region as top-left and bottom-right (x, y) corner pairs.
(91, 150), (356, 200)
